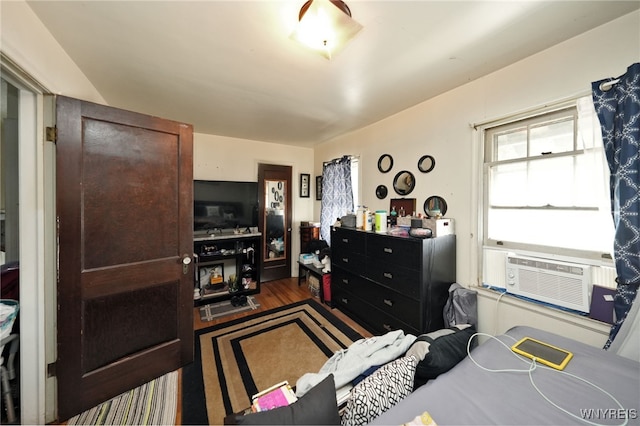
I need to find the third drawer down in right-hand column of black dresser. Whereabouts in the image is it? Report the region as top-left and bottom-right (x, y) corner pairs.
(356, 281), (420, 329)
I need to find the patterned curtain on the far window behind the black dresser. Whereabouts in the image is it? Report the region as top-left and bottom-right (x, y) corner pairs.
(320, 156), (353, 245)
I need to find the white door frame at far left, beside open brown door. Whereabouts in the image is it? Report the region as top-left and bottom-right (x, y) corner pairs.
(0, 53), (56, 424)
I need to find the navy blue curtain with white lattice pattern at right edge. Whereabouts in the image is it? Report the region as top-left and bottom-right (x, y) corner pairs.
(592, 63), (640, 349)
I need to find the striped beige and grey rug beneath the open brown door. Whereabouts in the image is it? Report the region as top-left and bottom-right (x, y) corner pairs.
(67, 371), (178, 425)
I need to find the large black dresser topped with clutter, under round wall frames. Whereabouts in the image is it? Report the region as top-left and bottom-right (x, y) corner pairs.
(331, 227), (456, 335)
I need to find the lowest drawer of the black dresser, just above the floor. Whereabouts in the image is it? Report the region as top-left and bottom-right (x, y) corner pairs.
(332, 289), (420, 336)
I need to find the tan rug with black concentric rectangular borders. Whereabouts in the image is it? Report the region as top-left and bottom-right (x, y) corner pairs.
(182, 299), (362, 424)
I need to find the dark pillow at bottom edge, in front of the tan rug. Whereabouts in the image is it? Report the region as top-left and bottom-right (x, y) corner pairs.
(224, 374), (340, 425)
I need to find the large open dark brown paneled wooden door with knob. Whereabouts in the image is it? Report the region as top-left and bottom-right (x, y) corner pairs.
(56, 97), (193, 420)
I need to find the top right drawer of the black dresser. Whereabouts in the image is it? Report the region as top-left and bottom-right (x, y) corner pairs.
(367, 234), (422, 269)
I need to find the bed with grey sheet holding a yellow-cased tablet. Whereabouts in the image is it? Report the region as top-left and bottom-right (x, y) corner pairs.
(371, 326), (640, 425)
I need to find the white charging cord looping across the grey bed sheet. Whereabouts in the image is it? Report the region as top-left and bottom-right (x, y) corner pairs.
(467, 333), (629, 426)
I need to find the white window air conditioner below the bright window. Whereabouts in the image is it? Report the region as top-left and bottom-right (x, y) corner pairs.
(506, 256), (591, 313)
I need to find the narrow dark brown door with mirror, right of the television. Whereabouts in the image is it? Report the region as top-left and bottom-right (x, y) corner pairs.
(258, 164), (292, 281)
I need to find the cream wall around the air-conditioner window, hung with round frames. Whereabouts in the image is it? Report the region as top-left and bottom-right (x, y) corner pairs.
(315, 12), (640, 345)
